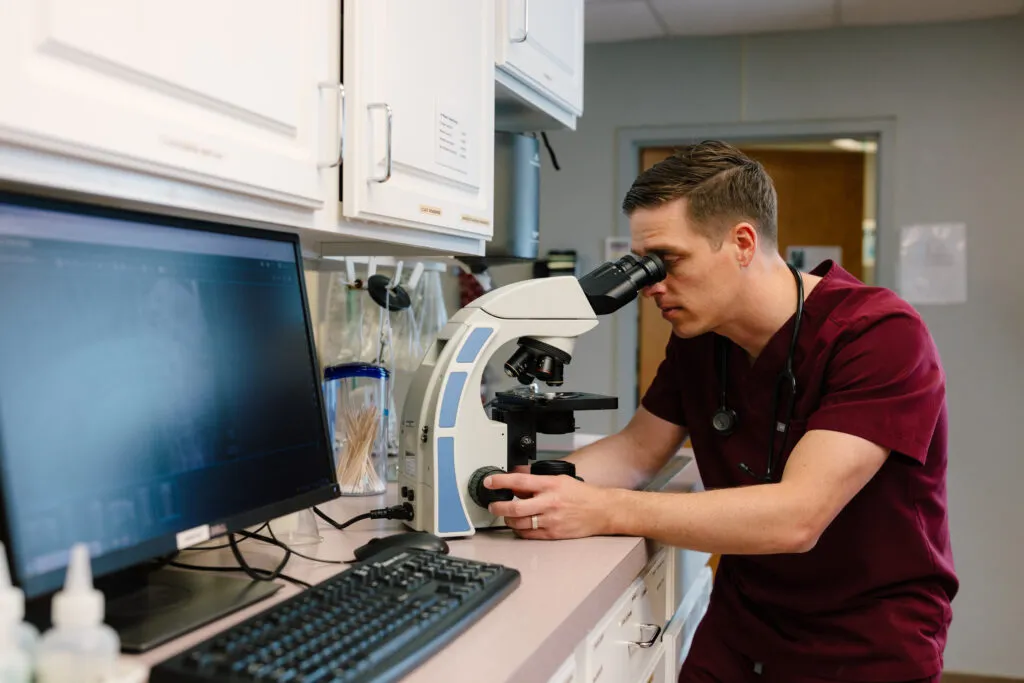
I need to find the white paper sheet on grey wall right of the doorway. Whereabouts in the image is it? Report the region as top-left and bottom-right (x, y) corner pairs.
(899, 223), (967, 304)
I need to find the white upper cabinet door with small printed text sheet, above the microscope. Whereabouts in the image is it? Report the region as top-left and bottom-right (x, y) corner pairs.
(342, 0), (495, 238)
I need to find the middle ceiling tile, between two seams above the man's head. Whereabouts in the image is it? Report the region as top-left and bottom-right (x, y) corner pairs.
(650, 0), (839, 36)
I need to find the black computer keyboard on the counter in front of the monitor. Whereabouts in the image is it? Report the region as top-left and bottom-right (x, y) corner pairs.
(150, 548), (519, 683)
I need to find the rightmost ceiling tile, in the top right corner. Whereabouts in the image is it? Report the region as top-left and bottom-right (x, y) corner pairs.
(840, 0), (1024, 26)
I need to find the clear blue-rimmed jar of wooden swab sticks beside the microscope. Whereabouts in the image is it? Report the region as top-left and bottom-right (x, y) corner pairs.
(324, 362), (390, 496)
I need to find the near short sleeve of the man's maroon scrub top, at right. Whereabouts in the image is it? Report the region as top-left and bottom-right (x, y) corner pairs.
(807, 313), (945, 464)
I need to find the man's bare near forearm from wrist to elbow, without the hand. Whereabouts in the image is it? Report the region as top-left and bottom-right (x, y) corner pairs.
(607, 483), (817, 555)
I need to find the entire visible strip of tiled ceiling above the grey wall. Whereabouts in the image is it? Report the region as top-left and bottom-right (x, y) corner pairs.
(585, 0), (1024, 43)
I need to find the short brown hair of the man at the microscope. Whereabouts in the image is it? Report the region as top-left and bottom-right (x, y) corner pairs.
(623, 140), (778, 247)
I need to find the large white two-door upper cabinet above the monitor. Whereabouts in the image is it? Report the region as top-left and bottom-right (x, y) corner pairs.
(0, 0), (495, 256)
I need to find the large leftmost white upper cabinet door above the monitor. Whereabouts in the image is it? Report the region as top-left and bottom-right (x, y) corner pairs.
(0, 0), (329, 208)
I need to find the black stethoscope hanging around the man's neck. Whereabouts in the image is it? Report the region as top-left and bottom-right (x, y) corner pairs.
(711, 263), (804, 482)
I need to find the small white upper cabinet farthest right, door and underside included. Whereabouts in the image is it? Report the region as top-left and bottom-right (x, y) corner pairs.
(495, 0), (584, 130)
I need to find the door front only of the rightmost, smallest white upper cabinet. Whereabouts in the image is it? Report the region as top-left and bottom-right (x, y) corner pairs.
(497, 0), (584, 116)
